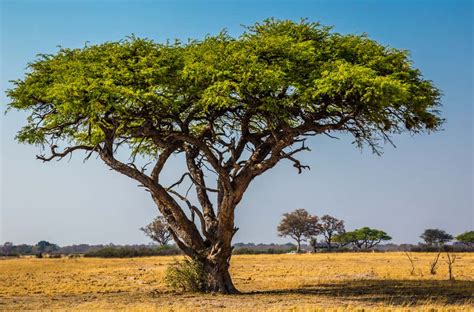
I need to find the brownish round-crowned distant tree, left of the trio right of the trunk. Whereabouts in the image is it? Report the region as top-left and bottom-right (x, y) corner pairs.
(277, 209), (319, 253)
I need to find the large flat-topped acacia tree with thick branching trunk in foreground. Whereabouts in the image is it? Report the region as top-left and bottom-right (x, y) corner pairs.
(7, 19), (442, 293)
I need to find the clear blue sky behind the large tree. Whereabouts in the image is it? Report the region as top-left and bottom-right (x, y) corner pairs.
(0, 0), (474, 245)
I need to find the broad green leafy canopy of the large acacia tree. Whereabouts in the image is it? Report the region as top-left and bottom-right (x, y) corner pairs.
(7, 19), (442, 156)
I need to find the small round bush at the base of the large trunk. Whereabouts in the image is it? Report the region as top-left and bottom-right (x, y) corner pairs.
(164, 258), (207, 292)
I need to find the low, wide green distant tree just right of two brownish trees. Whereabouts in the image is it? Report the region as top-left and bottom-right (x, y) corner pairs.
(334, 227), (392, 249)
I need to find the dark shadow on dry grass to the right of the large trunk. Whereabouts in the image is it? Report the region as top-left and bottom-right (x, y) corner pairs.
(247, 280), (474, 305)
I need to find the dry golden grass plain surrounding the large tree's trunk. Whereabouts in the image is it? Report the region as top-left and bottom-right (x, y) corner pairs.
(0, 253), (474, 311)
